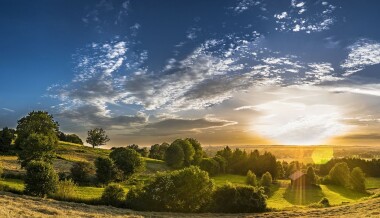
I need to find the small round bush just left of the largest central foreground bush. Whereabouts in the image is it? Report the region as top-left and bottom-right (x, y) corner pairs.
(101, 184), (125, 207)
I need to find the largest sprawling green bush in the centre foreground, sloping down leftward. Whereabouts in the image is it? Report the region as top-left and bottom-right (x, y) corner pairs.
(127, 166), (214, 212)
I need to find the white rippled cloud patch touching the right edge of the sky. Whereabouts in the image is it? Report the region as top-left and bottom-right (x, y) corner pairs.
(340, 39), (380, 76)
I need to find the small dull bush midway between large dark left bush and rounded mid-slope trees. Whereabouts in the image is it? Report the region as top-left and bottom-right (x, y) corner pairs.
(70, 162), (95, 185)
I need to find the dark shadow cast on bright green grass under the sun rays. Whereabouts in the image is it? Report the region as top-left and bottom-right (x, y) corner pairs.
(284, 185), (324, 205)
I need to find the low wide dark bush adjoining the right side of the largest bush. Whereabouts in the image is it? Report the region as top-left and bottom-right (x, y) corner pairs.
(212, 184), (267, 213)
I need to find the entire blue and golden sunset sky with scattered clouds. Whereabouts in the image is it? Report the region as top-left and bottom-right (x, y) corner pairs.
(0, 0), (380, 146)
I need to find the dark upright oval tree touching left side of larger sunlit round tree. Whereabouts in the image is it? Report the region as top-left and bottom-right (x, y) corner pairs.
(95, 157), (118, 184)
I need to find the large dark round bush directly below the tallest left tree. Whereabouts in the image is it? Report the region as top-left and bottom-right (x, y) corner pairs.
(25, 161), (58, 197)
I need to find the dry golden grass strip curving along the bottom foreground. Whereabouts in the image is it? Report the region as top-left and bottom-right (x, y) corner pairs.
(0, 192), (380, 218)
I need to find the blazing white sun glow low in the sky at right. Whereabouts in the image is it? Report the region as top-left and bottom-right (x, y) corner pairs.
(253, 101), (348, 145)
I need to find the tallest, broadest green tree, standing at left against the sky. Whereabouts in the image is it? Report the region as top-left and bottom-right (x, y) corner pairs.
(15, 111), (58, 167)
